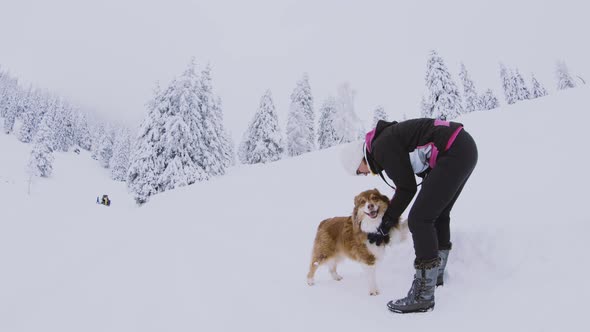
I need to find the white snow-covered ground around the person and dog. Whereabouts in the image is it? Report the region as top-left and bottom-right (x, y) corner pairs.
(0, 87), (590, 332)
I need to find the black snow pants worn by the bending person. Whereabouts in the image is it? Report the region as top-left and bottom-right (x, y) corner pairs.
(408, 129), (477, 262)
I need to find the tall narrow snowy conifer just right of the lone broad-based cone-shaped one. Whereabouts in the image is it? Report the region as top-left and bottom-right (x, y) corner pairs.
(287, 74), (315, 157)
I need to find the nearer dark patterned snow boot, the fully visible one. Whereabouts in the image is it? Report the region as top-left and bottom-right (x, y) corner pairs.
(387, 257), (440, 314)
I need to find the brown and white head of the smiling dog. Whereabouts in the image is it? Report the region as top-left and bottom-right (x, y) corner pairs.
(353, 189), (389, 233)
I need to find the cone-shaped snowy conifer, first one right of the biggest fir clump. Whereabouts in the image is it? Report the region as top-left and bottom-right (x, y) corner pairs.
(238, 90), (285, 164)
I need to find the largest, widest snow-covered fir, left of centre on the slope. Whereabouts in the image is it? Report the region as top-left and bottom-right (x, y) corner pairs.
(127, 60), (214, 204)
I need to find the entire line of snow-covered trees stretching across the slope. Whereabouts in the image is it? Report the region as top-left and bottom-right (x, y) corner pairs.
(0, 51), (585, 204)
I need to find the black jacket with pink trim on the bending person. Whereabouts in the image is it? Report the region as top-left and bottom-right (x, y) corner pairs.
(367, 118), (462, 220)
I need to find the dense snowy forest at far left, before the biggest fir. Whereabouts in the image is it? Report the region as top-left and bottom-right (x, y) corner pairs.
(0, 70), (131, 181)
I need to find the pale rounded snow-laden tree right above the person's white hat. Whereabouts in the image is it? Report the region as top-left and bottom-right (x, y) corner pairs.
(333, 83), (365, 144)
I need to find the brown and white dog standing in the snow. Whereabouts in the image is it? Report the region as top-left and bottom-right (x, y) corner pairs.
(307, 189), (408, 295)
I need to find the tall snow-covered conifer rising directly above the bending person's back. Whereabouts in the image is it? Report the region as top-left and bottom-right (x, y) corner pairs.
(422, 51), (462, 120)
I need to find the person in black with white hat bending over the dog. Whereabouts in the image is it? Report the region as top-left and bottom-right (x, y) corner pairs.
(341, 118), (477, 313)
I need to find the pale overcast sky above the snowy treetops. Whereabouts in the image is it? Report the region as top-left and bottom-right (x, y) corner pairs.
(0, 0), (590, 139)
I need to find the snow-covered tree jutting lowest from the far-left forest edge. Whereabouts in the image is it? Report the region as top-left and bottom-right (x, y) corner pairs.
(28, 115), (55, 177)
